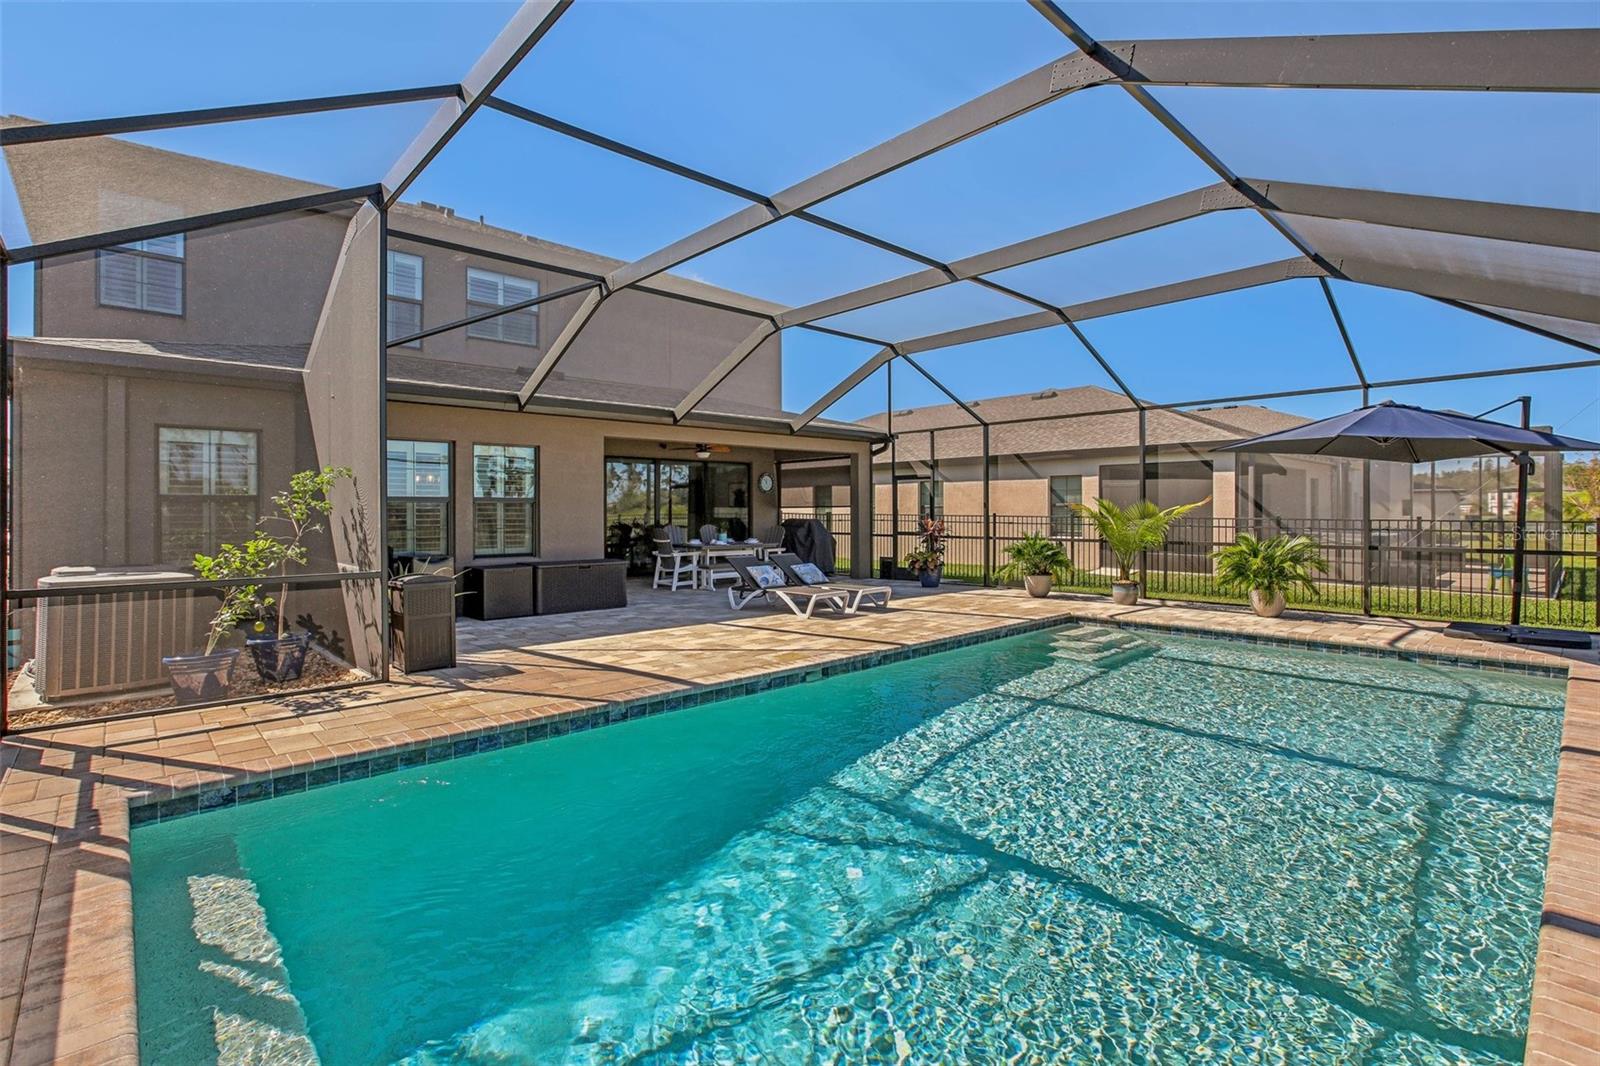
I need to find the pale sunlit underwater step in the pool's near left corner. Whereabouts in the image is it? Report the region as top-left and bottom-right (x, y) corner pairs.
(189, 874), (320, 1066)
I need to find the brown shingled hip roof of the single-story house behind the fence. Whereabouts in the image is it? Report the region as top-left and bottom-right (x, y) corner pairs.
(861, 386), (1309, 463)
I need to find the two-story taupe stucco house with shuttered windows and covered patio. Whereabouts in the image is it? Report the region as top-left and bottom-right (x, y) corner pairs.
(0, 118), (880, 665)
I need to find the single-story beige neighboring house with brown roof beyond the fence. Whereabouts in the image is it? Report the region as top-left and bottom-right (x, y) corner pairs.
(784, 386), (1555, 533)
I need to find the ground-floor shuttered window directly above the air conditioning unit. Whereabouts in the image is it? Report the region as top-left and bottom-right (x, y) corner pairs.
(155, 426), (261, 567)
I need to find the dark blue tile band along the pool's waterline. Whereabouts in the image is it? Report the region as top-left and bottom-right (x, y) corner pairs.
(128, 615), (1570, 828)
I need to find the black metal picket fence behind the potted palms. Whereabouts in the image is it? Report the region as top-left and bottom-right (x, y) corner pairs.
(784, 511), (1600, 629)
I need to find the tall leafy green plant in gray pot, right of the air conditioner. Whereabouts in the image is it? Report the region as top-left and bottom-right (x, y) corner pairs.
(245, 466), (350, 682)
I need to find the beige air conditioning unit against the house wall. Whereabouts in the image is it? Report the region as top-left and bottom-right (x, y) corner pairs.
(34, 567), (211, 703)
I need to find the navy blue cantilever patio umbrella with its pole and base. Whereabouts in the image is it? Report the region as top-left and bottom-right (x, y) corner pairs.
(1219, 402), (1600, 647)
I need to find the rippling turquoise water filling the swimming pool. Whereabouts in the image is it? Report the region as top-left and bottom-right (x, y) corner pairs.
(133, 626), (1563, 1064)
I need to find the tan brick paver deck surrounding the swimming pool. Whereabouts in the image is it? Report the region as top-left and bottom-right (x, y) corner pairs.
(0, 586), (1600, 1066)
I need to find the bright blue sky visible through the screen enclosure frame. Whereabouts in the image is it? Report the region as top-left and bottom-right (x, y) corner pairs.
(0, 0), (1600, 435)
